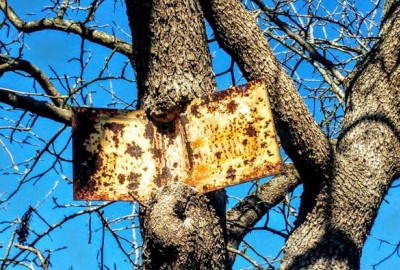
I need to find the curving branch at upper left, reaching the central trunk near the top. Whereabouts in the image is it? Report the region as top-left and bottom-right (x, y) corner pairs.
(0, 0), (132, 59)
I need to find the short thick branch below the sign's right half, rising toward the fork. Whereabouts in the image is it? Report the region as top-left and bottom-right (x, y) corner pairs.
(226, 164), (300, 263)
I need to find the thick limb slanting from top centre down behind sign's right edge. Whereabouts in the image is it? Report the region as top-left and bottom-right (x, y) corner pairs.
(201, 0), (332, 219)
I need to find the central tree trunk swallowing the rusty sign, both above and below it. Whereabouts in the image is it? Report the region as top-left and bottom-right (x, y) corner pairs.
(126, 0), (226, 269)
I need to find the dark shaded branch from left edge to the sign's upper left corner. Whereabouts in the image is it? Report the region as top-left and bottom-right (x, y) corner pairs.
(0, 87), (71, 125)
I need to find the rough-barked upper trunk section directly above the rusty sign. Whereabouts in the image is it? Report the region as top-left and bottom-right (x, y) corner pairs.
(126, 0), (216, 122)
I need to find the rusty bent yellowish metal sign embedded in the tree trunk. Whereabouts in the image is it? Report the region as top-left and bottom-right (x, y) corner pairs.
(72, 80), (283, 201)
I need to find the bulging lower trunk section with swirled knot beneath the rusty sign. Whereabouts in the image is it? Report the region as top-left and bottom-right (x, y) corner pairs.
(141, 183), (226, 269)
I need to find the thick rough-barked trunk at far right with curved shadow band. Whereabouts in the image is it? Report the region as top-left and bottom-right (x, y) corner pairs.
(282, 1), (400, 269)
